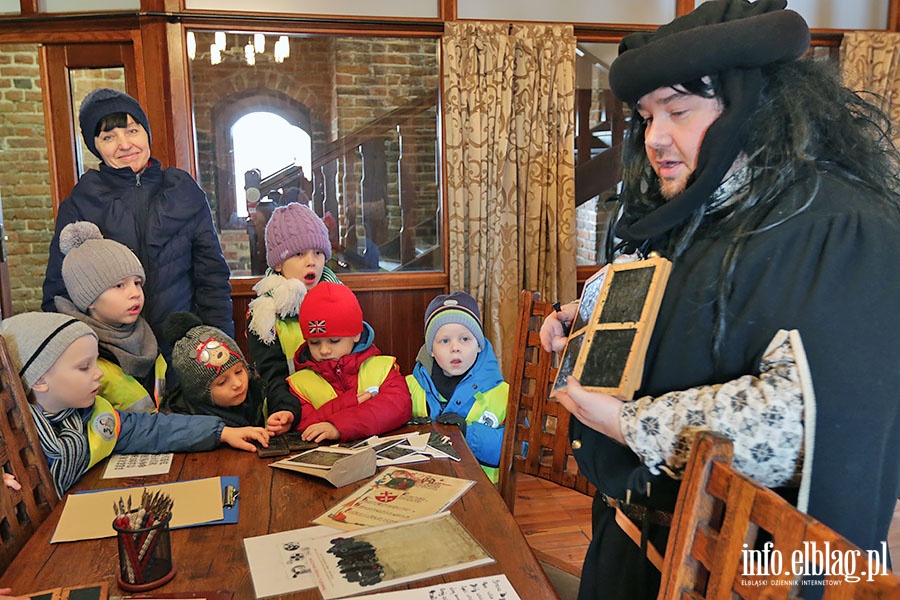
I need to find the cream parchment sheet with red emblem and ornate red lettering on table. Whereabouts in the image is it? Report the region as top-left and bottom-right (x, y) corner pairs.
(312, 467), (475, 531)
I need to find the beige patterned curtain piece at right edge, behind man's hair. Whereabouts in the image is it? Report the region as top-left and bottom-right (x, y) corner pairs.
(841, 31), (900, 145)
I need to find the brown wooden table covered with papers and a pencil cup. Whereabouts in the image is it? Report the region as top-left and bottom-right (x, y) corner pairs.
(0, 424), (557, 600)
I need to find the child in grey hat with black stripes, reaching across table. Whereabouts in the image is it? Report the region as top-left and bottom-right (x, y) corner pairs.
(0, 312), (269, 497)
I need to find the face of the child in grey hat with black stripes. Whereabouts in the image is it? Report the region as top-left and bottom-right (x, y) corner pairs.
(33, 335), (103, 415)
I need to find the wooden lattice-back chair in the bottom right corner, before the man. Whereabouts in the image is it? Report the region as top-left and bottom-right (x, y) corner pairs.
(659, 433), (900, 600)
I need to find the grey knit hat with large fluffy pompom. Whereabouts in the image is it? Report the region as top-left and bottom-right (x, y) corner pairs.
(59, 221), (146, 313)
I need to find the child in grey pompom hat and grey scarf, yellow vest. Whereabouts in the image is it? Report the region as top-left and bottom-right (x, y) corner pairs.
(54, 221), (166, 412)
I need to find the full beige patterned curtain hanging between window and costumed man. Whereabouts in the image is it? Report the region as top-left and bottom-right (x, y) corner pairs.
(443, 22), (576, 376)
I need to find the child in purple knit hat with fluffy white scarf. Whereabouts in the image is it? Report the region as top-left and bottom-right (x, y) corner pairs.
(247, 202), (340, 435)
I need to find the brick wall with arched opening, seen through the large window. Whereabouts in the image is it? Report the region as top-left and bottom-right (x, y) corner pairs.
(191, 33), (439, 274)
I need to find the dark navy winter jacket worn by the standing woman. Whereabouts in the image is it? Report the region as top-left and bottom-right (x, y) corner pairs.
(42, 158), (234, 360)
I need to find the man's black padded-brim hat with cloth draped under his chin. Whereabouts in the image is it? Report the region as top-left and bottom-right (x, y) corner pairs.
(609, 0), (810, 242)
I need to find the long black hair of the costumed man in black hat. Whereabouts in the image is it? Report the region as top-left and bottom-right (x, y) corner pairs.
(607, 59), (900, 359)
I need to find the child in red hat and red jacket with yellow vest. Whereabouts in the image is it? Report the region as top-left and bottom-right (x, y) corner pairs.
(288, 281), (412, 442)
